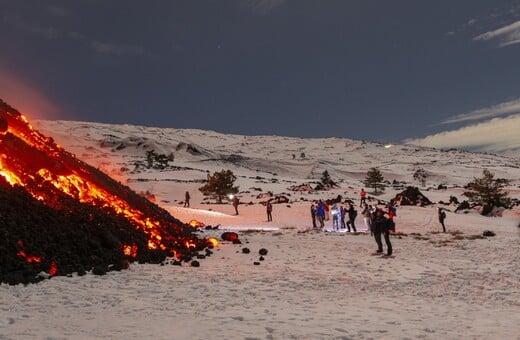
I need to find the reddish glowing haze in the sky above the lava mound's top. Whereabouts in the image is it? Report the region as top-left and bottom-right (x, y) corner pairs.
(0, 67), (61, 119)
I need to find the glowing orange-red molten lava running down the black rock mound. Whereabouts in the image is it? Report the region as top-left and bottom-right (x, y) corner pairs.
(0, 100), (207, 275)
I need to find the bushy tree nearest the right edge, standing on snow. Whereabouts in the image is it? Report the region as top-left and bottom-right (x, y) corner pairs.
(463, 169), (510, 215)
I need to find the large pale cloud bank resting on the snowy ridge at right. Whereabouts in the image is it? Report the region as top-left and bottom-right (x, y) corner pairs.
(404, 114), (520, 157)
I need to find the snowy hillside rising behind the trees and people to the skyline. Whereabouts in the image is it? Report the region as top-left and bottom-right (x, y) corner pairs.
(34, 121), (520, 205)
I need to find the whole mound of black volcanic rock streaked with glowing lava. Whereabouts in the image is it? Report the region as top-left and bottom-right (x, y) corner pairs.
(0, 100), (207, 284)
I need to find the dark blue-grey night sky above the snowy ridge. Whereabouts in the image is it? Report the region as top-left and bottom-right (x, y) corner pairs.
(0, 0), (520, 142)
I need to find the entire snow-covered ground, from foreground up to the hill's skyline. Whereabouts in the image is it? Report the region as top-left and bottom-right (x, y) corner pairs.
(0, 121), (520, 339)
